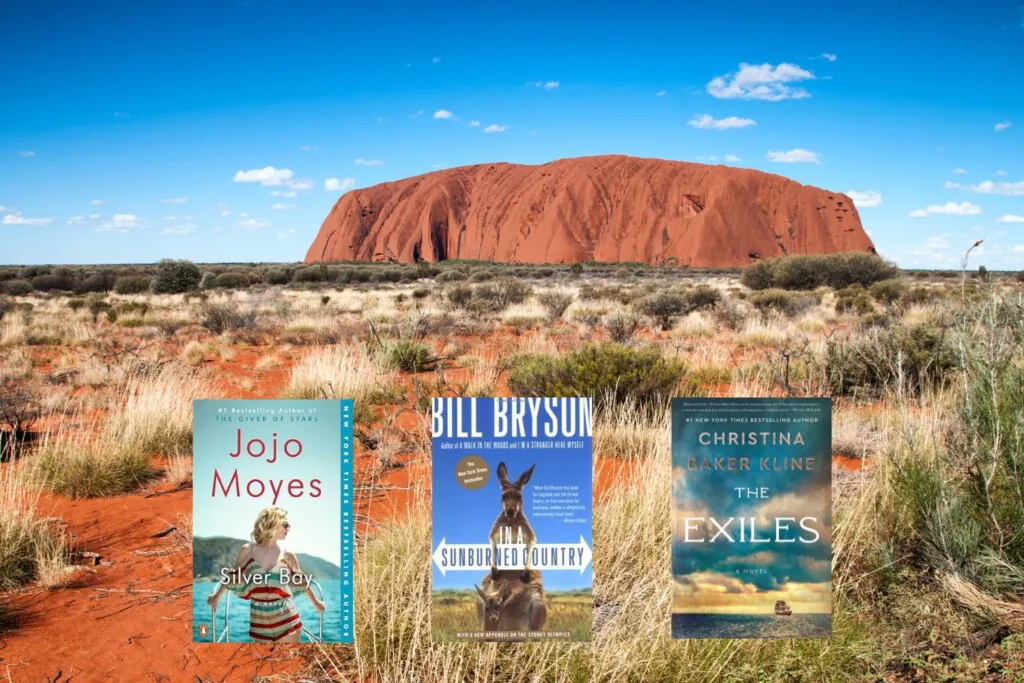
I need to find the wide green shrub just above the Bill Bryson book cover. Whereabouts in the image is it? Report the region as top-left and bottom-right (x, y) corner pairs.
(508, 343), (686, 407)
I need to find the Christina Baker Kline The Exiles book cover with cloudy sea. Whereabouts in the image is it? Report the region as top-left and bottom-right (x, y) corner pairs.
(672, 398), (831, 638)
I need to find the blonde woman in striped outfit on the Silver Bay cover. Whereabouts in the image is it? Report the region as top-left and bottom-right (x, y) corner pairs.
(206, 506), (324, 643)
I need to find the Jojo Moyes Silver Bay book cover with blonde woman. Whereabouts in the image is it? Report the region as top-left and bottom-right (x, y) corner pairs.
(193, 399), (354, 643)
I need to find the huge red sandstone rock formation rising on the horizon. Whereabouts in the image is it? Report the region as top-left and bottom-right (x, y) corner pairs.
(305, 155), (874, 267)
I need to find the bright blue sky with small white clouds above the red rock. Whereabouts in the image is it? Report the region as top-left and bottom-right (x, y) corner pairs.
(0, 0), (1024, 269)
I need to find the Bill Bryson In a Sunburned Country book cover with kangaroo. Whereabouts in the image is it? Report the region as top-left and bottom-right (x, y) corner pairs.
(430, 398), (593, 642)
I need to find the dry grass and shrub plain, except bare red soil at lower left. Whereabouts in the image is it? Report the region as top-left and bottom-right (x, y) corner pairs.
(0, 255), (1024, 682)
